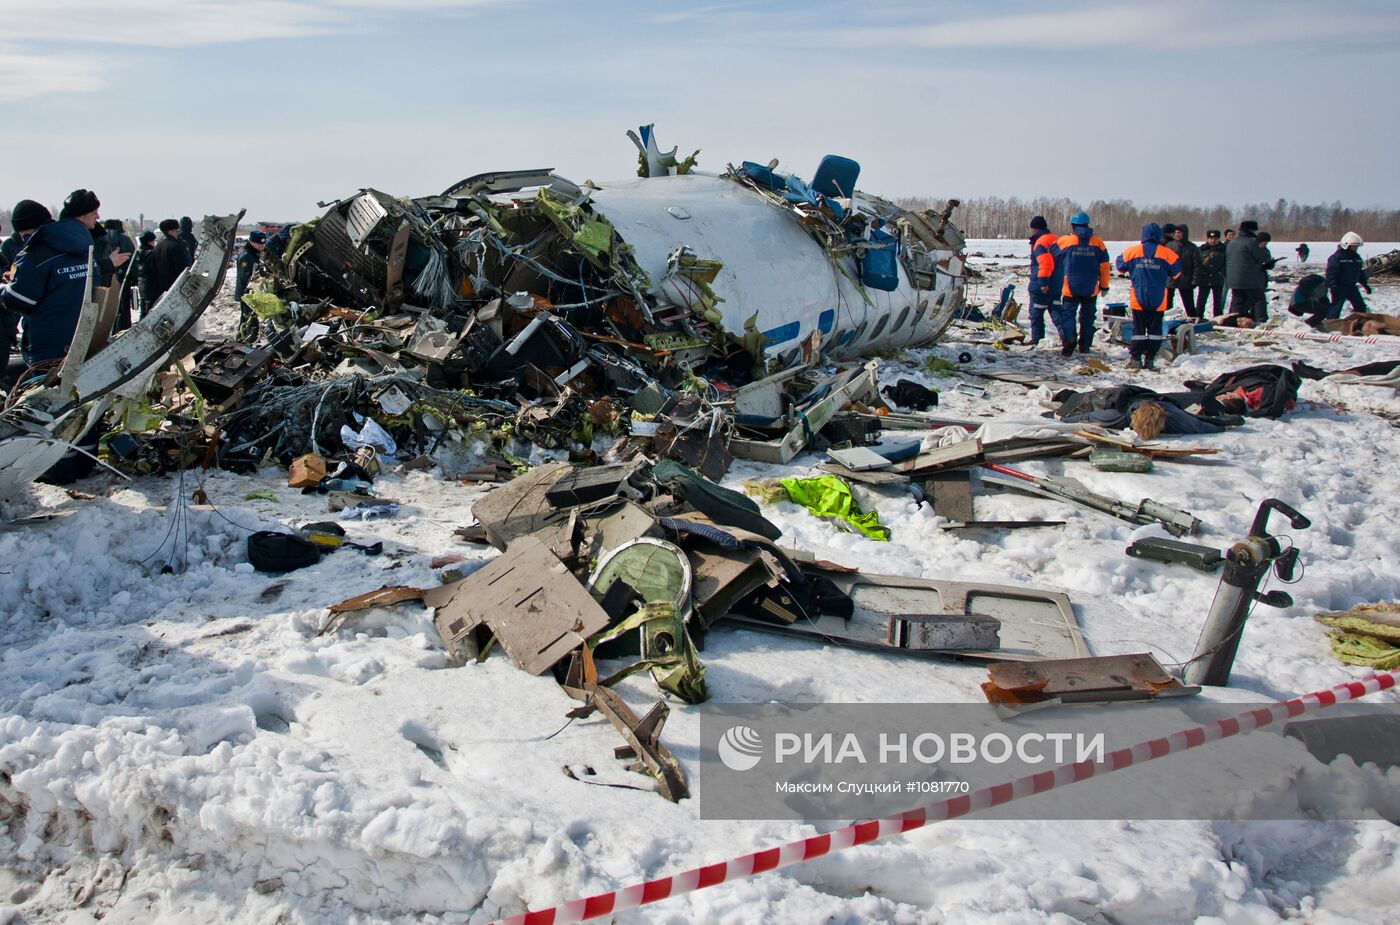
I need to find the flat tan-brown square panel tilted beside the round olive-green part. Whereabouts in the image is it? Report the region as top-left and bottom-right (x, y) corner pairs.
(424, 537), (608, 675)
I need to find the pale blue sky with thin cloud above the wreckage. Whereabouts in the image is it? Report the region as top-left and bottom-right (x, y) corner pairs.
(0, 0), (1400, 220)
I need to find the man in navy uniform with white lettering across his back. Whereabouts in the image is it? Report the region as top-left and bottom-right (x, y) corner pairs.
(0, 189), (130, 367)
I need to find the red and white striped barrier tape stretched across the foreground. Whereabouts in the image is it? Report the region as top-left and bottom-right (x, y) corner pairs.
(496, 672), (1400, 925)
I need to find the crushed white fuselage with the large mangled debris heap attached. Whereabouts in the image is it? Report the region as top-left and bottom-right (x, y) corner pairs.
(0, 126), (963, 494)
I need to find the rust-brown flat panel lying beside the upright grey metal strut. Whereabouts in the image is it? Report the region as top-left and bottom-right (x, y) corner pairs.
(981, 652), (1201, 707)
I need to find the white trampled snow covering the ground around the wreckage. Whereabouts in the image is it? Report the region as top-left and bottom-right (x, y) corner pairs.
(0, 251), (1400, 925)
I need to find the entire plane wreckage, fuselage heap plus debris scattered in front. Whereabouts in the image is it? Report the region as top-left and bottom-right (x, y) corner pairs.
(0, 126), (1355, 799)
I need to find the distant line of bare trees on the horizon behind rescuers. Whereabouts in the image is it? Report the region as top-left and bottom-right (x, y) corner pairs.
(899, 196), (1400, 241)
